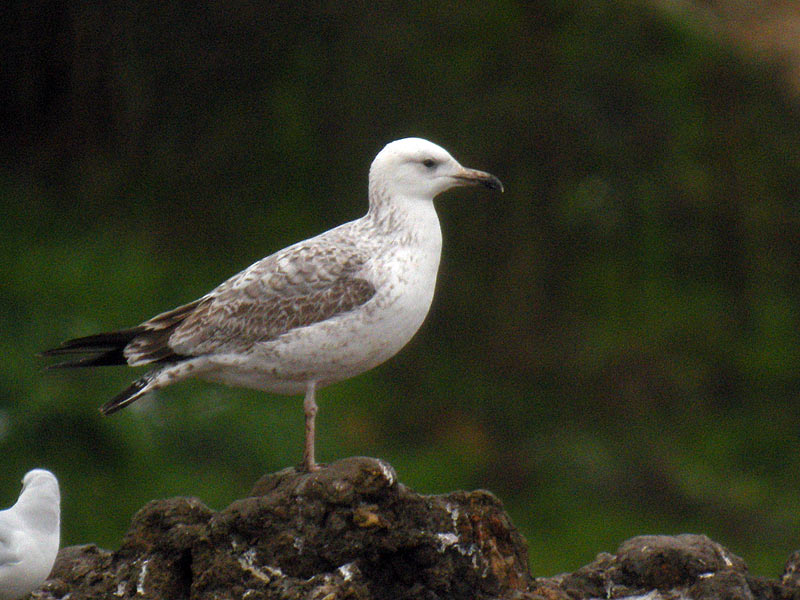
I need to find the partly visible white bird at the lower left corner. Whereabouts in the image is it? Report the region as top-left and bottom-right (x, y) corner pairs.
(0, 469), (61, 600)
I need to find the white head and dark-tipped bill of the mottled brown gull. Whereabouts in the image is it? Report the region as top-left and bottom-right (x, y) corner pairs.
(369, 138), (503, 200)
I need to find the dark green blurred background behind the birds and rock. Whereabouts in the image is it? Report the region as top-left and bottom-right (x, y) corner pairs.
(0, 0), (800, 575)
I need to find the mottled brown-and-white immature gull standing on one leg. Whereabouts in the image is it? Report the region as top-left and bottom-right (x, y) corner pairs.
(44, 138), (503, 471)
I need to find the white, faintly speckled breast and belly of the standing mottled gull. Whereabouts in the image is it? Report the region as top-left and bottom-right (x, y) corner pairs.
(203, 202), (442, 394)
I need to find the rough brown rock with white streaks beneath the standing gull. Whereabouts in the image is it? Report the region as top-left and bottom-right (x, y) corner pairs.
(33, 458), (800, 600)
